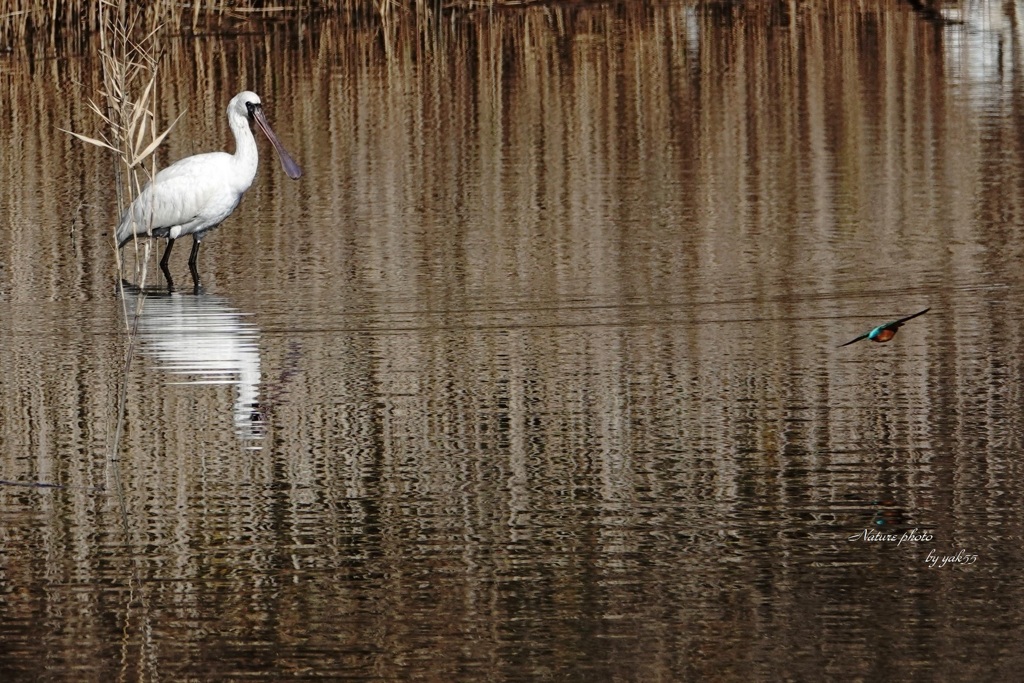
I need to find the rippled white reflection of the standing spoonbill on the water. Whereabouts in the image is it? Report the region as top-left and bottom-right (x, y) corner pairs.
(128, 294), (264, 447)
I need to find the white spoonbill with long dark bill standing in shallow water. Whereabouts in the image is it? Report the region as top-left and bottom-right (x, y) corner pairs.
(117, 90), (302, 292)
